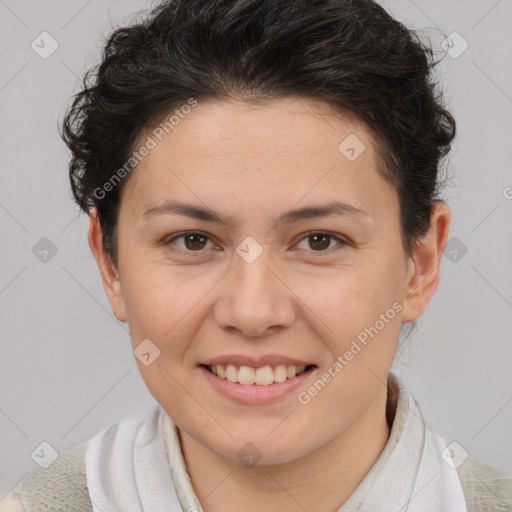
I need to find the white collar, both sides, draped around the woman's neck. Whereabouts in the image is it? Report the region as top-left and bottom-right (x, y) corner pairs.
(86, 376), (467, 512)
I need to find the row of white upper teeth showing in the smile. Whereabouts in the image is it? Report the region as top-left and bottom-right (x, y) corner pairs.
(208, 364), (306, 386)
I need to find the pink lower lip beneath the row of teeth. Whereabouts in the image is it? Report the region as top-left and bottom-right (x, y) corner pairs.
(199, 366), (317, 405)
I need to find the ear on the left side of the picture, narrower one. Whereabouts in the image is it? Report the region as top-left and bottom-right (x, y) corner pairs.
(87, 208), (127, 322)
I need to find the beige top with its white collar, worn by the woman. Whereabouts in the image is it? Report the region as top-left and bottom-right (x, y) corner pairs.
(4, 374), (512, 512)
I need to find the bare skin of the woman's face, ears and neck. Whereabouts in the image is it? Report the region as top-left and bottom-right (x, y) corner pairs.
(88, 98), (450, 512)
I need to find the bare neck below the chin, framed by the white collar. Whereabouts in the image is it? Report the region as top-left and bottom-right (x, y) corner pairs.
(178, 387), (394, 512)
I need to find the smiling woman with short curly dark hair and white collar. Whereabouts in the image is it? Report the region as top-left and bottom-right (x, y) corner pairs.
(3, 0), (512, 512)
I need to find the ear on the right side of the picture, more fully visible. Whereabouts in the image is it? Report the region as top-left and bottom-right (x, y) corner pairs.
(402, 201), (450, 322)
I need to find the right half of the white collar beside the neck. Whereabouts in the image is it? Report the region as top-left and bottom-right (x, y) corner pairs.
(338, 374), (467, 512)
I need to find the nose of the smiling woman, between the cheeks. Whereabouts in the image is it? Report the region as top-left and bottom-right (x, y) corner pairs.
(215, 249), (295, 337)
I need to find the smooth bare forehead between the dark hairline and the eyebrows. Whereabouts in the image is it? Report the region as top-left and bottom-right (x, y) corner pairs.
(123, 98), (396, 221)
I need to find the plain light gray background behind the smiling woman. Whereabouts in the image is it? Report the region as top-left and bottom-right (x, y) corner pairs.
(0, 0), (512, 498)
